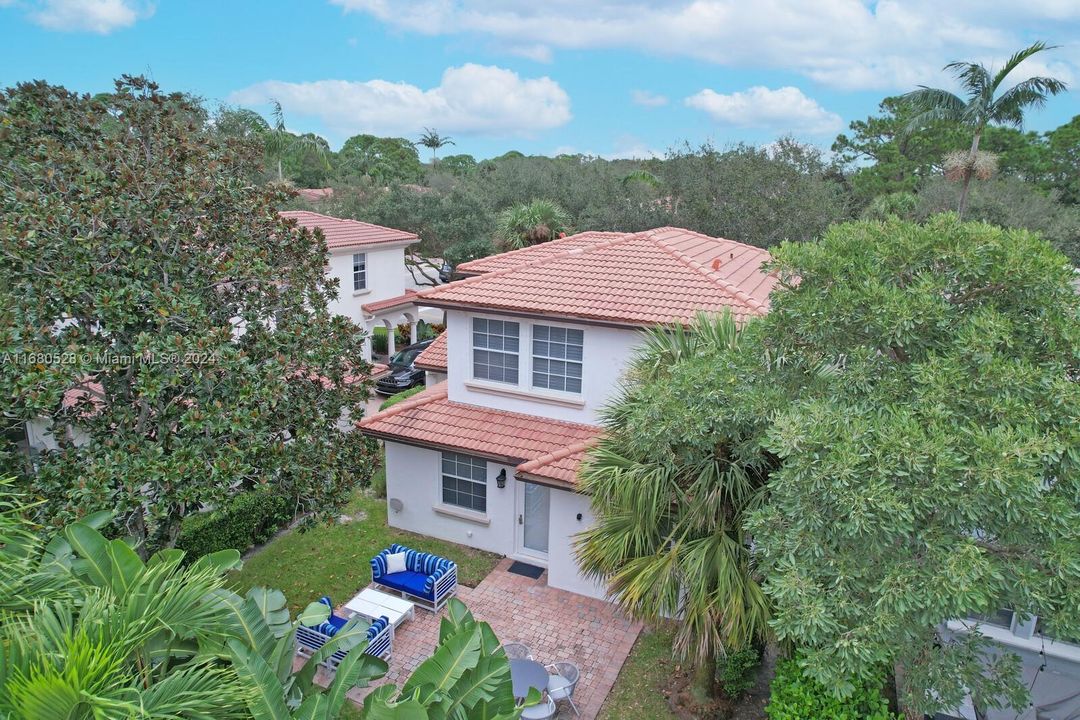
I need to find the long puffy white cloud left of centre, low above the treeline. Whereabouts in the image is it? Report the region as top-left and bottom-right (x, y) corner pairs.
(229, 64), (571, 140)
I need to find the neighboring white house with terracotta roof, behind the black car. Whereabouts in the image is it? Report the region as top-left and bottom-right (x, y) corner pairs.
(281, 210), (420, 359)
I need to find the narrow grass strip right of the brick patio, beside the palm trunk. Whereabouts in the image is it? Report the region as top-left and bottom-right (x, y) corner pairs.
(597, 625), (677, 720)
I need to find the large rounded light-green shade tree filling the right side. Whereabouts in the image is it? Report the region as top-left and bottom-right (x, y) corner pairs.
(747, 215), (1080, 718)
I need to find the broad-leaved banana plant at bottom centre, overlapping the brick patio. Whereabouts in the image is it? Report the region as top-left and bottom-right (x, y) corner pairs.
(360, 598), (540, 720)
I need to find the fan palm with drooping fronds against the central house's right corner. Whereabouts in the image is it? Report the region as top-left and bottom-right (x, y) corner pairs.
(576, 314), (770, 702)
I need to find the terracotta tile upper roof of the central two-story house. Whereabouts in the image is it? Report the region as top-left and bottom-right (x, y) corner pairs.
(417, 228), (777, 325)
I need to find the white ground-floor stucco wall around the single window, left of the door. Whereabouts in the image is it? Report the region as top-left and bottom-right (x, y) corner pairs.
(386, 441), (516, 555)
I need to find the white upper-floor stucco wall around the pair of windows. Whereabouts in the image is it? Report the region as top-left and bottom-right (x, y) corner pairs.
(446, 310), (642, 423)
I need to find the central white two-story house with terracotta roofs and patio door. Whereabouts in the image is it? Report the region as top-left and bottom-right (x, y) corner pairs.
(359, 228), (775, 597)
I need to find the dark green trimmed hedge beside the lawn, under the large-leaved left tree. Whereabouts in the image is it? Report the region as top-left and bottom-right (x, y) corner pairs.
(176, 489), (293, 559)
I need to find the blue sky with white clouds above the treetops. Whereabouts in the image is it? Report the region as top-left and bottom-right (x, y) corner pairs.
(0, 0), (1080, 158)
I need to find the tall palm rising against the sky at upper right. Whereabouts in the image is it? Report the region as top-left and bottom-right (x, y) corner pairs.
(904, 41), (1067, 218)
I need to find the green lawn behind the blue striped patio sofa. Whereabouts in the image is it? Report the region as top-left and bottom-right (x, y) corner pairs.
(230, 490), (499, 613)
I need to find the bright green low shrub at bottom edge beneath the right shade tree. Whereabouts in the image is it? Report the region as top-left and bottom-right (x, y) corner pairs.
(765, 660), (902, 720)
